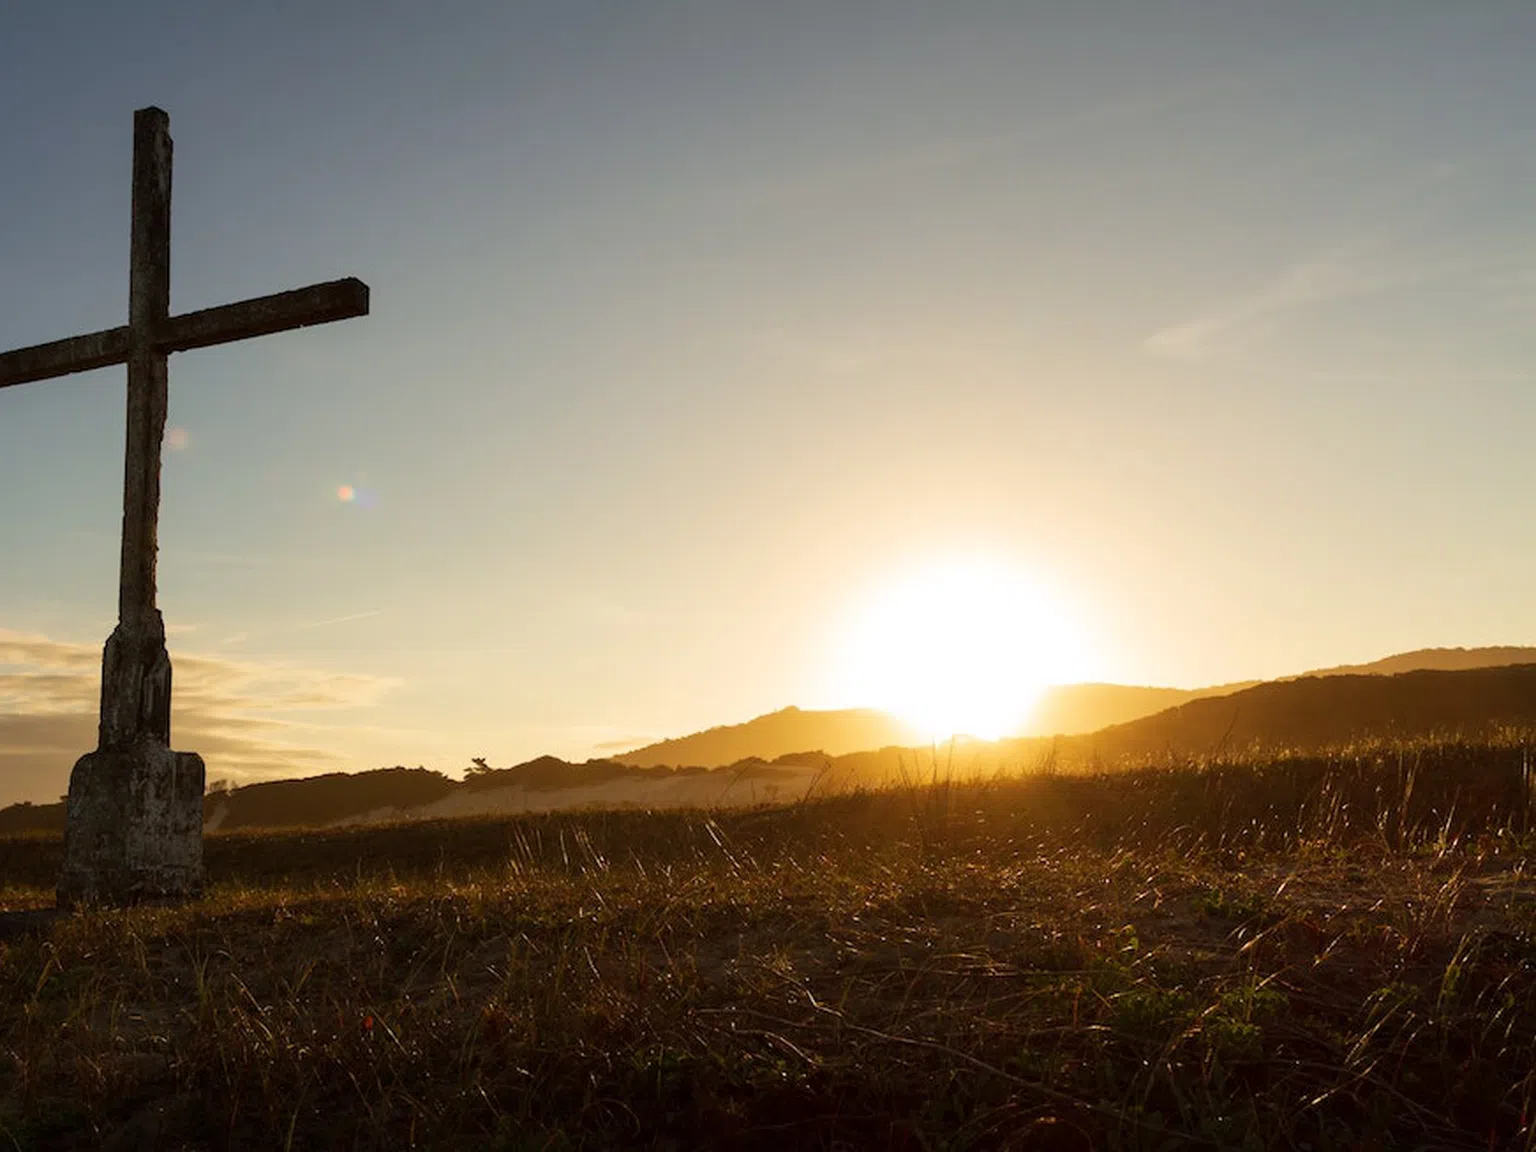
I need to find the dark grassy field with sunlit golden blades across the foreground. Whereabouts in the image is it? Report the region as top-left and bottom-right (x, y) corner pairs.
(0, 742), (1536, 1152)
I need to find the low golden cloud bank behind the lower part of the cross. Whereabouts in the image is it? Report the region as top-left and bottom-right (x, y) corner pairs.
(0, 630), (398, 803)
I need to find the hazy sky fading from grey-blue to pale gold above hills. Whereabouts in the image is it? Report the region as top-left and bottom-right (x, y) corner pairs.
(0, 0), (1536, 800)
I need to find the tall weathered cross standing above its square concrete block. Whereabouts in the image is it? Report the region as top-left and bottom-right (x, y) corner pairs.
(0, 108), (369, 751)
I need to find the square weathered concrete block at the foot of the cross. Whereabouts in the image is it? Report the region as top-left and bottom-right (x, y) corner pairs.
(58, 740), (204, 908)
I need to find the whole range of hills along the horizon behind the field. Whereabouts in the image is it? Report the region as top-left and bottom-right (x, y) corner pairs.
(9, 648), (1536, 836)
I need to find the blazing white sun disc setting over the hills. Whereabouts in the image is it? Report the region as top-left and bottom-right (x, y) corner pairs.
(837, 561), (1084, 740)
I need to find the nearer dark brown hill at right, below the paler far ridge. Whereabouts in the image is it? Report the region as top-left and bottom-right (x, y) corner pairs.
(1071, 664), (1536, 760)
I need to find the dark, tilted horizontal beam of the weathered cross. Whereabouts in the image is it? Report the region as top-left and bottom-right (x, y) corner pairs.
(0, 276), (369, 389)
